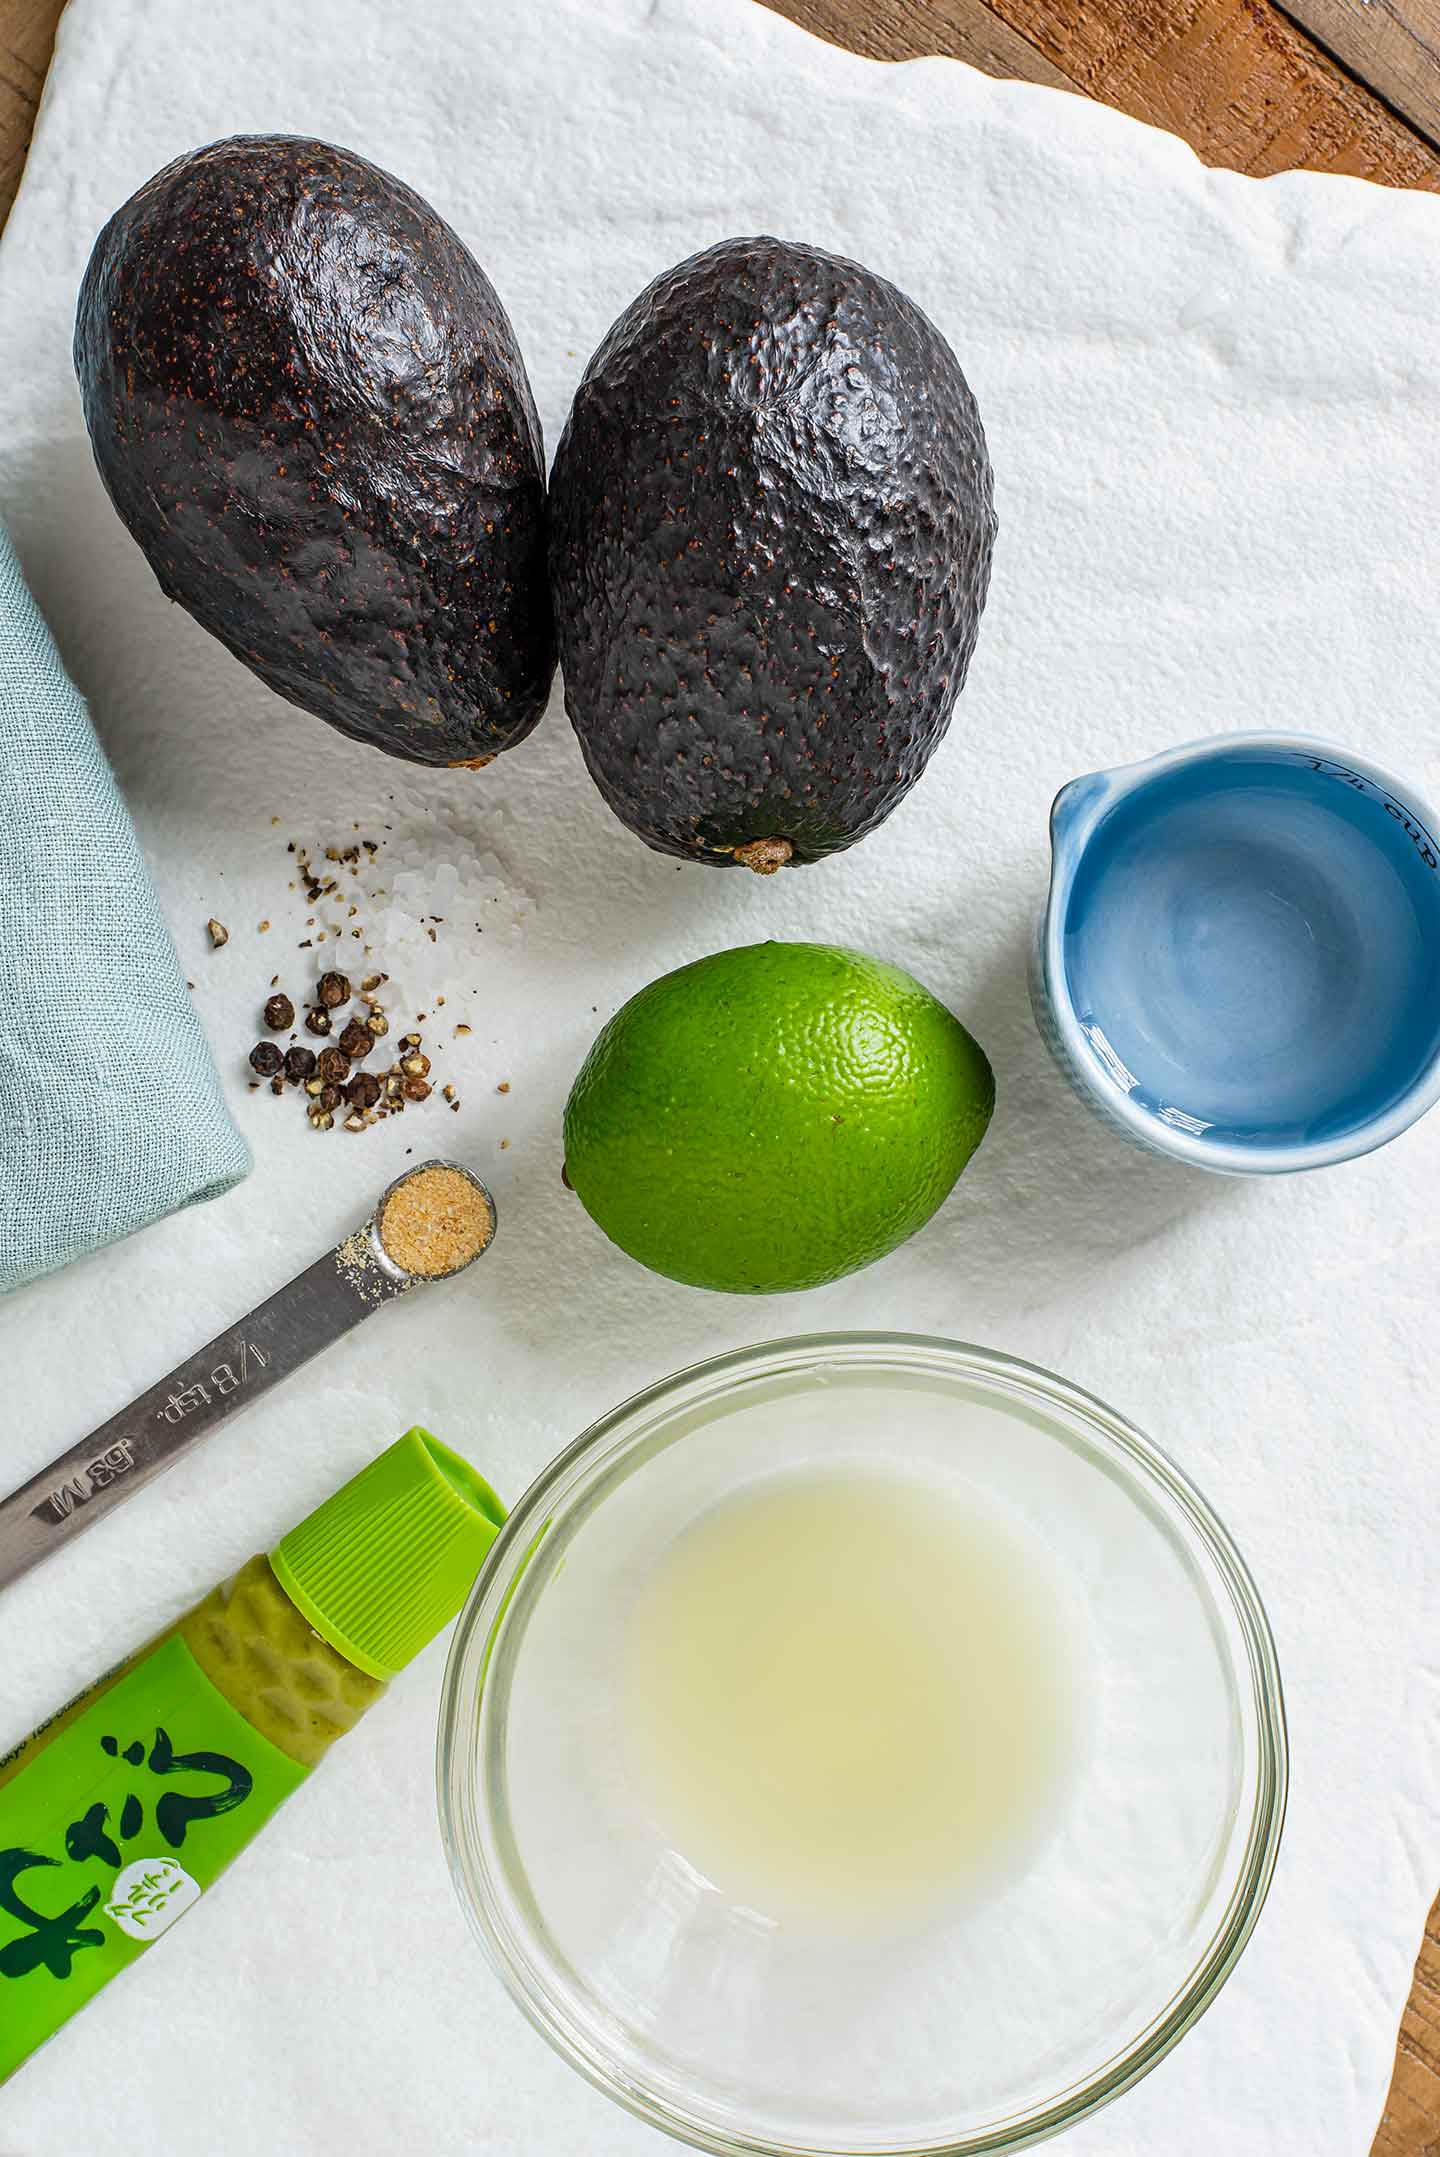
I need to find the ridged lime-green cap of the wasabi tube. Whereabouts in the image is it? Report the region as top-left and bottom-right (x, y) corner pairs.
(269, 1428), (504, 1680)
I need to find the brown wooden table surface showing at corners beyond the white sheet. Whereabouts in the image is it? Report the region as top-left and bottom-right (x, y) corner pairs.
(0, 0), (1440, 2157)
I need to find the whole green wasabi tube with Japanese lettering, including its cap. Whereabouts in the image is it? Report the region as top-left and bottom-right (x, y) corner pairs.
(0, 1430), (504, 2082)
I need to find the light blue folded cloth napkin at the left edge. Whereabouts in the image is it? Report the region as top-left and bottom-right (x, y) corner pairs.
(0, 528), (250, 1292)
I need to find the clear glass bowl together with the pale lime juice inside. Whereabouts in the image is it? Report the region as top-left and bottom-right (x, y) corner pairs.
(440, 1335), (1285, 2157)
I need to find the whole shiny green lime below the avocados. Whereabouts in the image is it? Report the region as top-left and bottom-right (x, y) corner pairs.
(565, 943), (996, 1294)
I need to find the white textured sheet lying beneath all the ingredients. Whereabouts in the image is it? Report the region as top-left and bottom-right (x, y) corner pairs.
(0, 0), (1440, 2157)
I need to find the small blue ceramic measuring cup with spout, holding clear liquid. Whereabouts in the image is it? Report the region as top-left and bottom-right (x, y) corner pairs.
(1033, 733), (1440, 1176)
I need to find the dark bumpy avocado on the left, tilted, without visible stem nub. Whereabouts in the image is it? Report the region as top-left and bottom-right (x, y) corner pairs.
(75, 136), (554, 766)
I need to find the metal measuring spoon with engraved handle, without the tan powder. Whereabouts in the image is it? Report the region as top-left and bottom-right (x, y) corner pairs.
(0, 1160), (496, 1588)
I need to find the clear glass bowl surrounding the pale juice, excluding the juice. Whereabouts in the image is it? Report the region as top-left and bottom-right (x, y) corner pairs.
(438, 1333), (1287, 2157)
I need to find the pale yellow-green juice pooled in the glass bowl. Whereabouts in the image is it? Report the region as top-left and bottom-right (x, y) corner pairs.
(617, 1465), (1089, 1933)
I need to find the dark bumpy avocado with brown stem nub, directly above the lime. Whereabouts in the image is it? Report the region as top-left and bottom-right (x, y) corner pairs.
(550, 239), (996, 874)
